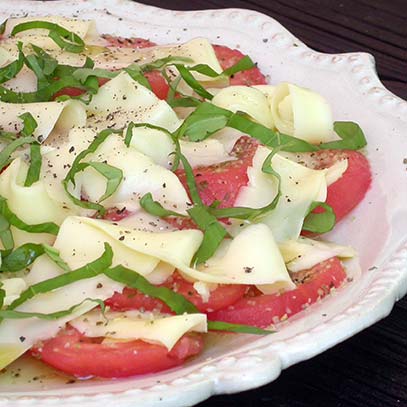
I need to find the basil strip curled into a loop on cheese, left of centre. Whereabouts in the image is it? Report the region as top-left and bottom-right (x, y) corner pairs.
(62, 129), (123, 215)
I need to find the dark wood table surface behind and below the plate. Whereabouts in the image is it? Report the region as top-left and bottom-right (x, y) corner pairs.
(139, 0), (407, 407)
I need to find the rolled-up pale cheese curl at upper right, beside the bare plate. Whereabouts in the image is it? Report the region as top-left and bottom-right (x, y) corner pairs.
(271, 83), (334, 144)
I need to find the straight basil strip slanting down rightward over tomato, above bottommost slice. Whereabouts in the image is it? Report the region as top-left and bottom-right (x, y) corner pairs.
(104, 265), (199, 314)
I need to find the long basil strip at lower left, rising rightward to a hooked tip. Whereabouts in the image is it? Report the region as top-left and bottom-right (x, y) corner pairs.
(7, 243), (113, 310)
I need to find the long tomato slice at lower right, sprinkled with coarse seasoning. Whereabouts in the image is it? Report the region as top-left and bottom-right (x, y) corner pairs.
(208, 257), (346, 328)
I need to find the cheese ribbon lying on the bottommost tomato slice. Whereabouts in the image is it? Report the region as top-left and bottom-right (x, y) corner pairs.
(70, 311), (207, 351)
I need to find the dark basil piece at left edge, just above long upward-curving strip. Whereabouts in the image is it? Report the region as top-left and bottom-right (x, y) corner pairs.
(0, 243), (70, 273)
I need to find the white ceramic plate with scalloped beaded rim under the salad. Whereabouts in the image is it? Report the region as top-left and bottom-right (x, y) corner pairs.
(0, 0), (407, 407)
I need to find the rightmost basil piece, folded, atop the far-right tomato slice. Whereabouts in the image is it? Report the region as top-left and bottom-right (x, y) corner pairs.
(319, 122), (367, 150)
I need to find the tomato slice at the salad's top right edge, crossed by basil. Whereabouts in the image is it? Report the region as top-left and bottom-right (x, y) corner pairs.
(213, 45), (267, 86)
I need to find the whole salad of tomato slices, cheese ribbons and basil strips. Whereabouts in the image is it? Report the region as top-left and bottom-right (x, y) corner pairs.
(0, 17), (371, 378)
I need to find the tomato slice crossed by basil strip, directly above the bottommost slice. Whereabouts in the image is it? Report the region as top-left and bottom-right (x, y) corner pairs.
(105, 273), (248, 313)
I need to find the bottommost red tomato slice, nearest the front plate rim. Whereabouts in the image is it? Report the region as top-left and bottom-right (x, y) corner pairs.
(31, 328), (203, 378)
